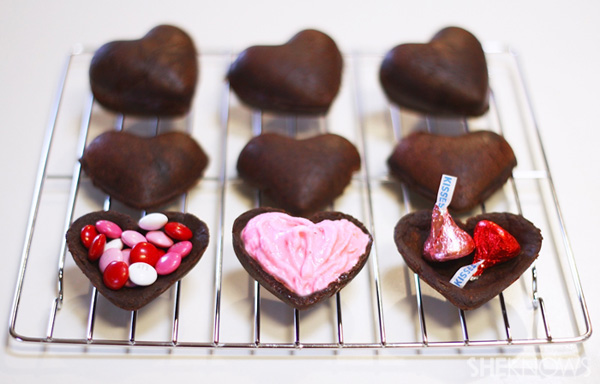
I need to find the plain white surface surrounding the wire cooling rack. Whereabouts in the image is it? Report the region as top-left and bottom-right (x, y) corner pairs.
(0, 0), (600, 383)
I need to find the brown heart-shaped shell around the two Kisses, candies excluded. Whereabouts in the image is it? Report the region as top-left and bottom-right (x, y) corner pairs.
(394, 210), (542, 310)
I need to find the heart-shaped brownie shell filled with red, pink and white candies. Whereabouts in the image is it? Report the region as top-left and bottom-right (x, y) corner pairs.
(66, 211), (209, 310)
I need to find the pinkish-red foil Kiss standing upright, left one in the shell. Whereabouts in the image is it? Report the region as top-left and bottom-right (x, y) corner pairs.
(423, 204), (475, 262)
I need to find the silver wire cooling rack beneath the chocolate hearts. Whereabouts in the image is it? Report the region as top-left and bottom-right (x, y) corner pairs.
(9, 46), (591, 353)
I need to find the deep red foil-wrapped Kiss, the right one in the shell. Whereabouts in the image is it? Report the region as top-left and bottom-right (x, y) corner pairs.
(473, 220), (521, 277)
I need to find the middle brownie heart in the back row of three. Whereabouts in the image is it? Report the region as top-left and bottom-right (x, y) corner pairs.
(227, 29), (343, 115)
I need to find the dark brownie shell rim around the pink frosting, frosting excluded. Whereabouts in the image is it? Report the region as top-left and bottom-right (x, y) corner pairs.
(233, 207), (373, 309)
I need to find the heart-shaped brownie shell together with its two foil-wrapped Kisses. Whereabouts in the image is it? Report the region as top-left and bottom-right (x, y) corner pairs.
(394, 175), (542, 310)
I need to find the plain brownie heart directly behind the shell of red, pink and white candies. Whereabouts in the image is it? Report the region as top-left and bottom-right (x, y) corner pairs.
(80, 131), (208, 209)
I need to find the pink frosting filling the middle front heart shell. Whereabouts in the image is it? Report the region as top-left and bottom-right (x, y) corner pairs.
(241, 212), (370, 296)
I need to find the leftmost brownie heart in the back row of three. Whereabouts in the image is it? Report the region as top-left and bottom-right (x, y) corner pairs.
(90, 25), (198, 116)
